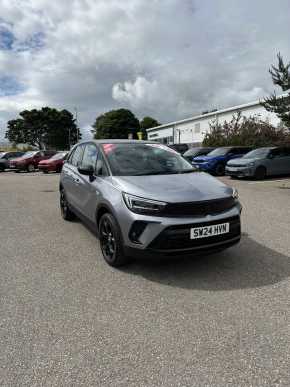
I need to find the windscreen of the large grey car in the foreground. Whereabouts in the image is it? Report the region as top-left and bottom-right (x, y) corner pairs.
(103, 143), (193, 176)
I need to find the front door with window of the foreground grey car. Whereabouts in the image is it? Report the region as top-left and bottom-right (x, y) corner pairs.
(74, 143), (98, 222)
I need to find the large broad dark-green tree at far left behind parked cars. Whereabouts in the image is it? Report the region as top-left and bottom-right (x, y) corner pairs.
(5, 107), (81, 149)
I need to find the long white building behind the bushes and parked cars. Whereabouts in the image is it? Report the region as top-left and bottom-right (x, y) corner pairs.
(147, 101), (280, 145)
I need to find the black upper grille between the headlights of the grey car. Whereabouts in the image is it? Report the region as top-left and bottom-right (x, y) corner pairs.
(162, 197), (236, 217)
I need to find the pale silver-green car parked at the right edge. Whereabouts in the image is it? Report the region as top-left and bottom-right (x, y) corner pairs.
(226, 147), (290, 179)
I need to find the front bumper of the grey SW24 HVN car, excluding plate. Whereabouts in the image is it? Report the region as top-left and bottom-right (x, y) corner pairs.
(120, 202), (241, 256)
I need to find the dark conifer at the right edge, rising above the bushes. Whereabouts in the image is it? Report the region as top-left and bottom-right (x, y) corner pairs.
(261, 53), (290, 130)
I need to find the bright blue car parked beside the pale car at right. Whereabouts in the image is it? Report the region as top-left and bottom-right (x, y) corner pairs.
(192, 146), (252, 176)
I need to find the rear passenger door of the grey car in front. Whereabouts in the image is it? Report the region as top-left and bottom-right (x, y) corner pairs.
(61, 144), (84, 210)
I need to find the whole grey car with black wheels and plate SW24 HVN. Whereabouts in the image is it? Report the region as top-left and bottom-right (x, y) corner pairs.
(59, 140), (241, 266)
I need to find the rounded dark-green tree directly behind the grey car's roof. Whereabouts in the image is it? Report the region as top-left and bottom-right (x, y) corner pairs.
(92, 109), (140, 139)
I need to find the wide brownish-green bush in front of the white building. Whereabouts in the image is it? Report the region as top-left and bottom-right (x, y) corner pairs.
(203, 112), (290, 147)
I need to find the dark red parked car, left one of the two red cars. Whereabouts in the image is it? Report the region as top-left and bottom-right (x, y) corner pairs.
(9, 151), (56, 172)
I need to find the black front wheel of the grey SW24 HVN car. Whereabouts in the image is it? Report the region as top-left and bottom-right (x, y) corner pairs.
(99, 213), (129, 267)
